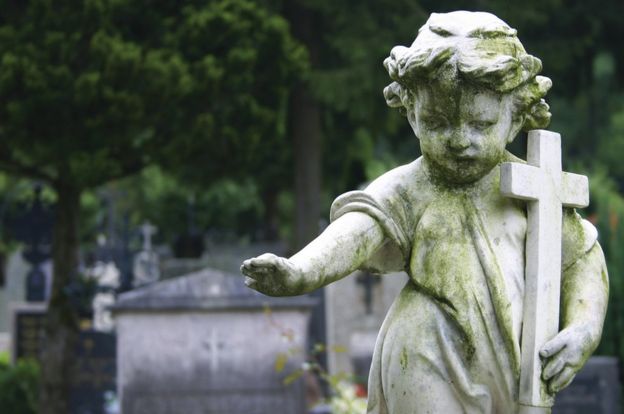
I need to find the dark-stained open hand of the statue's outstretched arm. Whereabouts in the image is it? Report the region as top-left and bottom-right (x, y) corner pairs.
(241, 253), (305, 296)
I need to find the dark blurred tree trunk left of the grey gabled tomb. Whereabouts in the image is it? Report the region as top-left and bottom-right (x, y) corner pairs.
(39, 184), (80, 414)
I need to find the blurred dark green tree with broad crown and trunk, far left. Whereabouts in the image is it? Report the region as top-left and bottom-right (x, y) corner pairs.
(0, 0), (305, 414)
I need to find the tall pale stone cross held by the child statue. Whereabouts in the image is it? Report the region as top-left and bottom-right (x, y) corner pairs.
(500, 130), (589, 414)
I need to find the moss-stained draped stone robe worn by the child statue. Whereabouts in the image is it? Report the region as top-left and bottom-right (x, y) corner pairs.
(331, 153), (596, 414)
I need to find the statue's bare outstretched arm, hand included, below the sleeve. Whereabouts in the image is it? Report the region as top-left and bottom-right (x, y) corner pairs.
(241, 212), (384, 296)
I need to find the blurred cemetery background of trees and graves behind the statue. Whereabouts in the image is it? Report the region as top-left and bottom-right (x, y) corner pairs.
(0, 0), (624, 414)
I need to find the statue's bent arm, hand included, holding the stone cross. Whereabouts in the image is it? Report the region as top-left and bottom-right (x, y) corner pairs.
(540, 242), (609, 393)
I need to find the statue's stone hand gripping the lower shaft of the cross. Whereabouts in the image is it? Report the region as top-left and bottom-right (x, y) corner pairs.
(540, 326), (595, 394)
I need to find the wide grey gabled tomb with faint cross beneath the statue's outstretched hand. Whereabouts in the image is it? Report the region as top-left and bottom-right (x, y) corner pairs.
(113, 269), (314, 414)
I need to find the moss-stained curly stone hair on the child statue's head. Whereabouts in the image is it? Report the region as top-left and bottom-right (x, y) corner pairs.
(384, 11), (552, 131)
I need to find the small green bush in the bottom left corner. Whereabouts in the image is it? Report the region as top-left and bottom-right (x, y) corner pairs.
(0, 353), (39, 414)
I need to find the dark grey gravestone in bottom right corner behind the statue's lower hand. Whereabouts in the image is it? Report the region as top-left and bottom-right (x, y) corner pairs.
(553, 356), (621, 414)
